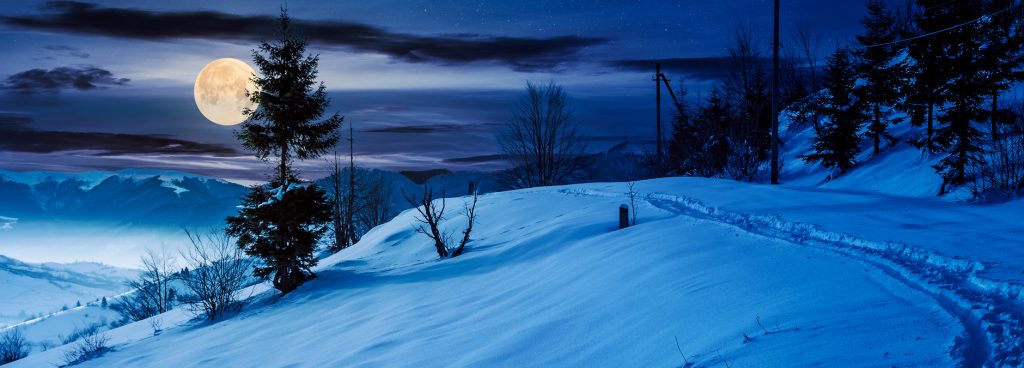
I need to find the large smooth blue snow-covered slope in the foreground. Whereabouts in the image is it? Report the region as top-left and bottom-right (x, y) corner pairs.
(12, 178), (1007, 367)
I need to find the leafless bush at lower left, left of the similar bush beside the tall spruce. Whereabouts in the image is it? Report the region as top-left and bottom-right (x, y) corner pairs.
(112, 247), (177, 321)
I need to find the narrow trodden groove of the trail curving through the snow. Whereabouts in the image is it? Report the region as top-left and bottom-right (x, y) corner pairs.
(558, 190), (993, 368)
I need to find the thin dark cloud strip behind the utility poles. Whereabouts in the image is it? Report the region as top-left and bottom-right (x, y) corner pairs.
(611, 56), (771, 80)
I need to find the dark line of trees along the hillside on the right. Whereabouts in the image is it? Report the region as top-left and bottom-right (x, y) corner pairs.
(662, 0), (1024, 197)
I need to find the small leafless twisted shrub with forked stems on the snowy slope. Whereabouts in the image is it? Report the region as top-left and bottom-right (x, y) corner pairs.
(402, 185), (477, 258)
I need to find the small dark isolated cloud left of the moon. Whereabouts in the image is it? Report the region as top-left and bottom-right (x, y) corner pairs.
(0, 66), (129, 94)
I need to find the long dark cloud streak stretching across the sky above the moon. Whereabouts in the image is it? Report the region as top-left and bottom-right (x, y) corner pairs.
(0, 1), (608, 71)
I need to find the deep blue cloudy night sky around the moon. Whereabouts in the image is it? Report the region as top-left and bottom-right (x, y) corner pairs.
(0, 0), (863, 180)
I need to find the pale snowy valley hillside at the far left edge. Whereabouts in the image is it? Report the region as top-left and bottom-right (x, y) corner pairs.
(0, 255), (137, 326)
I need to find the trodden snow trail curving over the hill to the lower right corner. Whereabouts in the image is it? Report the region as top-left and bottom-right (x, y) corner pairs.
(558, 189), (1024, 367)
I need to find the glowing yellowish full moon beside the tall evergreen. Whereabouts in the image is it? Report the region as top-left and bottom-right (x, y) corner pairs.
(195, 57), (257, 125)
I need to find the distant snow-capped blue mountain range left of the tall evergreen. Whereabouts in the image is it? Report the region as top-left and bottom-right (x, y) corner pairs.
(0, 170), (248, 228)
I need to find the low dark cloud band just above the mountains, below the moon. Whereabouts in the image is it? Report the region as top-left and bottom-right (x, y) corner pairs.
(0, 115), (239, 157)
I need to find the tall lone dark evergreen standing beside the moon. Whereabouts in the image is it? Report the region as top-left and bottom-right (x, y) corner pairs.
(227, 9), (342, 293)
